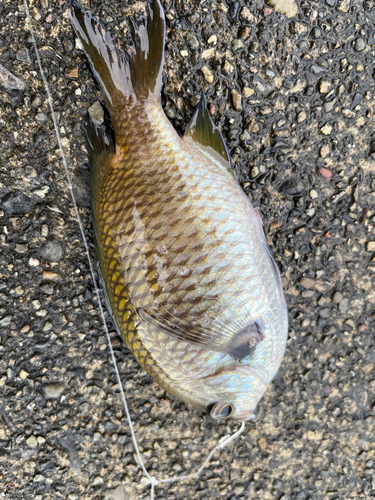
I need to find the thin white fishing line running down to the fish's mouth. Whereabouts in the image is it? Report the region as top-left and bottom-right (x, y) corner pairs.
(24, 0), (245, 500)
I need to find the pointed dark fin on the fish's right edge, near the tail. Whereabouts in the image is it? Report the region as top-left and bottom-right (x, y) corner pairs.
(184, 92), (232, 176)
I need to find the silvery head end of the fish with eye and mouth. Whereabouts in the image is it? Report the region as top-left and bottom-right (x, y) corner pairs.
(202, 363), (271, 422)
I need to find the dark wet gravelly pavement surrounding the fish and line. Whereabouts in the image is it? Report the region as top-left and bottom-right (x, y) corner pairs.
(0, 0), (375, 500)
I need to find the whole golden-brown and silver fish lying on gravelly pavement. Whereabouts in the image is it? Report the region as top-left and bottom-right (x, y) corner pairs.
(69, 0), (288, 422)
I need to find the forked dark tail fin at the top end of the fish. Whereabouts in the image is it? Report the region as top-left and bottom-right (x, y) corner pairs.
(70, 0), (165, 116)
